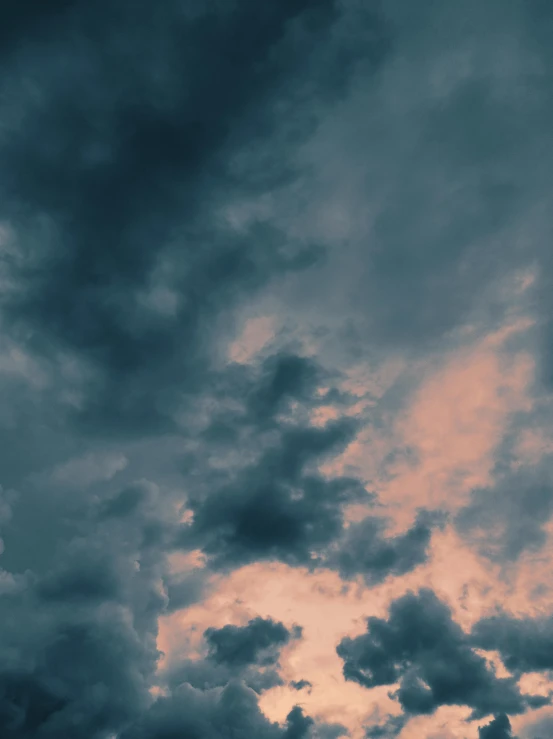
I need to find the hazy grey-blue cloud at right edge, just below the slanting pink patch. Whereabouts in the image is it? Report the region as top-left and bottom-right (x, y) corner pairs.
(455, 456), (553, 562)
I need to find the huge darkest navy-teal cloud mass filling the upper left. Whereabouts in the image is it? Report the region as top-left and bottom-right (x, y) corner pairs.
(0, 0), (390, 433)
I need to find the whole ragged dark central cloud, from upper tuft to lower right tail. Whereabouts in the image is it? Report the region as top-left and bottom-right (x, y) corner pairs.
(175, 352), (445, 583)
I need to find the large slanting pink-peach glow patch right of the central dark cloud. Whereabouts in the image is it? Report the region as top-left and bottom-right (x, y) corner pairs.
(323, 320), (534, 517)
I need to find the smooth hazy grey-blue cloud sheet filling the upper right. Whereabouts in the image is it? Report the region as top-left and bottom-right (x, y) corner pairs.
(258, 0), (553, 394)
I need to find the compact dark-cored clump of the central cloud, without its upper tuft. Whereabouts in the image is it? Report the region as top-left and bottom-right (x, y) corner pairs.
(181, 423), (360, 565)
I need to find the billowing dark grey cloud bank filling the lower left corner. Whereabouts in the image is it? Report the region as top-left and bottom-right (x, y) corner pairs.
(0, 484), (166, 739)
